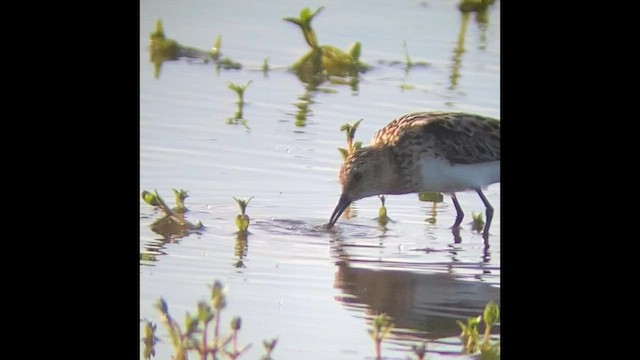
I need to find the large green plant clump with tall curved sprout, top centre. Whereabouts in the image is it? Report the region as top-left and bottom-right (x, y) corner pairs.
(283, 6), (369, 84)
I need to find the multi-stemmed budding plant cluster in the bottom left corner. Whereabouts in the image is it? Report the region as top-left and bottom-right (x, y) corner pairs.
(151, 280), (277, 360)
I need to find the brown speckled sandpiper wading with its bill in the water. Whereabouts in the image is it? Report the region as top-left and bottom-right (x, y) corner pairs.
(327, 111), (500, 244)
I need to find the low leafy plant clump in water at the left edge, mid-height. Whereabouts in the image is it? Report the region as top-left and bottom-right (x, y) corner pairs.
(142, 189), (204, 237)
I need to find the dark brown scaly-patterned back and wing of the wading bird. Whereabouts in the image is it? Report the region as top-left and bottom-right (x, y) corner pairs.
(371, 112), (500, 164)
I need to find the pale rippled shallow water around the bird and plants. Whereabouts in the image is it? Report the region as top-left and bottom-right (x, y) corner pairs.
(140, 0), (501, 359)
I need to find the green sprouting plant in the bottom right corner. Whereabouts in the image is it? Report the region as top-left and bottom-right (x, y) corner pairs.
(456, 301), (500, 359)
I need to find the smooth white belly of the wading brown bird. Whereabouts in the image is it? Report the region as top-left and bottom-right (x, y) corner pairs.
(419, 157), (500, 193)
